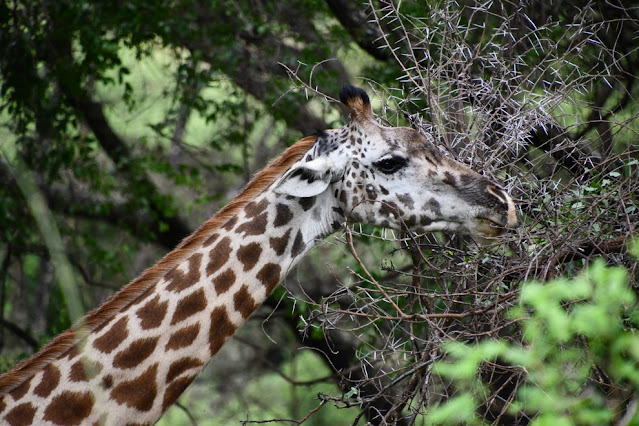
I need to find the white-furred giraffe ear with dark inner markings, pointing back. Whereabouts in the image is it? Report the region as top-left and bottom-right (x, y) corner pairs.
(274, 157), (333, 197)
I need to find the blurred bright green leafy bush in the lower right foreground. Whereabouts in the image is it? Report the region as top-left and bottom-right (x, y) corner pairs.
(427, 246), (639, 425)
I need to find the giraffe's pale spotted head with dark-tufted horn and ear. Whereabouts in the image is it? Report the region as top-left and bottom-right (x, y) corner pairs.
(275, 85), (517, 238)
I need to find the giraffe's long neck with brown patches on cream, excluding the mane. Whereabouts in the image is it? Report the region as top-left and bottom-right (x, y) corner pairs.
(0, 139), (336, 424)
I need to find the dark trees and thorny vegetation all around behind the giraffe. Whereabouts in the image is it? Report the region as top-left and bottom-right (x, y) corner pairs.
(0, 0), (639, 425)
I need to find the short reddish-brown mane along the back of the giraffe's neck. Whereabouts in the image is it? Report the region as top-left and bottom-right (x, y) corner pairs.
(0, 136), (317, 395)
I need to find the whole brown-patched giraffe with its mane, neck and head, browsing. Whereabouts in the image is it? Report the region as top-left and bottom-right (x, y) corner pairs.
(0, 85), (517, 426)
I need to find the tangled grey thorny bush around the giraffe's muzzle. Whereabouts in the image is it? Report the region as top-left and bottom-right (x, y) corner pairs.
(287, 1), (639, 424)
